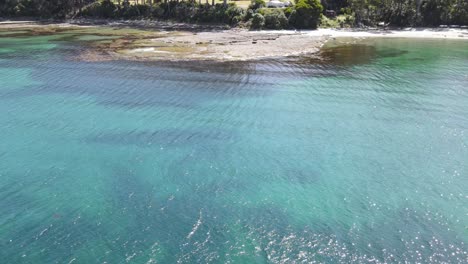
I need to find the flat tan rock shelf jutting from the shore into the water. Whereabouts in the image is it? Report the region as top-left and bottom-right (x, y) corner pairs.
(109, 30), (328, 61)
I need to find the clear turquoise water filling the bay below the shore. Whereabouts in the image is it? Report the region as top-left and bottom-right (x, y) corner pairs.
(0, 36), (468, 263)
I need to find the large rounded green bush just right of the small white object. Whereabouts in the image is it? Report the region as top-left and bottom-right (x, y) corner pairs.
(289, 0), (323, 29)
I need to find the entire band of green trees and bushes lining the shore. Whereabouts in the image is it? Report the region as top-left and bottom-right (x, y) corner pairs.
(0, 0), (468, 29)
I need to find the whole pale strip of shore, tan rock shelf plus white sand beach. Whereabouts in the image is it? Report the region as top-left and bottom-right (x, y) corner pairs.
(0, 20), (468, 61)
